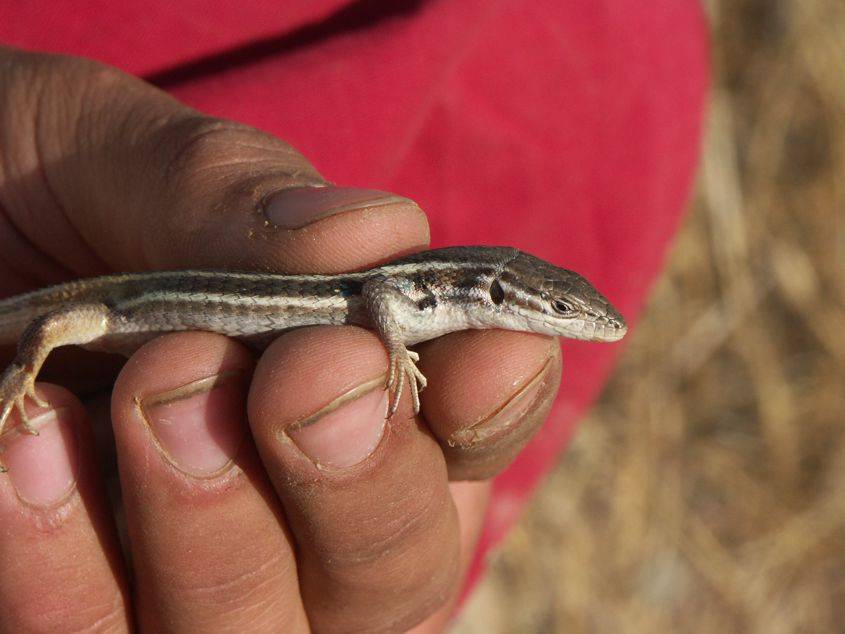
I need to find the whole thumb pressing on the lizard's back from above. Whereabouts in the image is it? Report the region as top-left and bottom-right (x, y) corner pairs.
(0, 49), (428, 281)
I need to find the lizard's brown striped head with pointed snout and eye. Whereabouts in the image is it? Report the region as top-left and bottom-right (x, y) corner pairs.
(490, 252), (628, 341)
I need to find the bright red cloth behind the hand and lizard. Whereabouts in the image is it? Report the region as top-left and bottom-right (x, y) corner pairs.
(0, 0), (708, 592)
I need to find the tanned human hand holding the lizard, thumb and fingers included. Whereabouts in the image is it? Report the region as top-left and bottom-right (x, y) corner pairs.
(0, 49), (561, 632)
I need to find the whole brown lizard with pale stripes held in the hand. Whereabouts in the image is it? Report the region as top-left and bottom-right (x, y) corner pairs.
(0, 247), (627, 468)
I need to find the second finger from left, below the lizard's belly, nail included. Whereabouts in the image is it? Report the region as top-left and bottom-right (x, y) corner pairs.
(112, 332), (307, 632)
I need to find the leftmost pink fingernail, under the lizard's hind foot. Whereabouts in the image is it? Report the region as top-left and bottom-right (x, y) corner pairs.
(3, 407), (79, 507)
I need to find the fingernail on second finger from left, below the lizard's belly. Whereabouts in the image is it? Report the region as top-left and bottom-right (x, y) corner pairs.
(139, 371), (247, 477)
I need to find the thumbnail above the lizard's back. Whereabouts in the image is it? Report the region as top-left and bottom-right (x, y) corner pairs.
(264, 186), (415, 229)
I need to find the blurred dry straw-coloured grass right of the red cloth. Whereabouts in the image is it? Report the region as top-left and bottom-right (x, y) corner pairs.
(456, 0), (845, 634)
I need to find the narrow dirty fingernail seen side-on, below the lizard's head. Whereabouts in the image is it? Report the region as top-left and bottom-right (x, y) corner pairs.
(447, 356), (557, 447)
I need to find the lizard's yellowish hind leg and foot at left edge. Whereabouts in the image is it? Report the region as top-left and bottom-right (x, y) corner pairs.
(0, 304), (111, 464)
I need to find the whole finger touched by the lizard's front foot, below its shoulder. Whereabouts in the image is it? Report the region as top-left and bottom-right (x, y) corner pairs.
(249, 326), (460, 632)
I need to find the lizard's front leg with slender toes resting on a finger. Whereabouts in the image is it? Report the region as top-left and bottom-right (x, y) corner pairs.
(361, 277), (428, 417)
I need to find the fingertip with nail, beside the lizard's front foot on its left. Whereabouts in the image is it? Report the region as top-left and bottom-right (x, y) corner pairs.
(249, 326), (387, 470)
